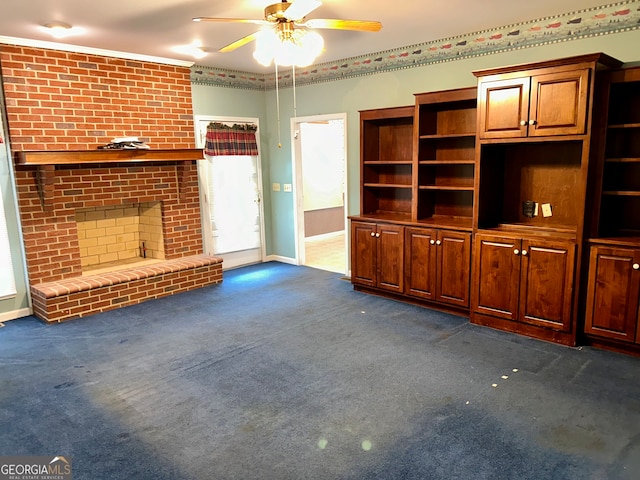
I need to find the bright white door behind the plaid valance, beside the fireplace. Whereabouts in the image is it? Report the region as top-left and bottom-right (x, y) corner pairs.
(196, 116), (264, 269)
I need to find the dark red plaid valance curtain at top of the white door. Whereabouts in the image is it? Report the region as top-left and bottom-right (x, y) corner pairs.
(204, 122), (258, 156)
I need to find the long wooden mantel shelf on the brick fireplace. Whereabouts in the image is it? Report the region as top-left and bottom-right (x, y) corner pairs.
(15, 148), (204, 165)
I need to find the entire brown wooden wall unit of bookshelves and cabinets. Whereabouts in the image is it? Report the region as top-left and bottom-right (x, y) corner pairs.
(350, 53), (640, 355)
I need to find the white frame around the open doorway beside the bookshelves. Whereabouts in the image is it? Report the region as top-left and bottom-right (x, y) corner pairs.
(291, 112), (350, 275)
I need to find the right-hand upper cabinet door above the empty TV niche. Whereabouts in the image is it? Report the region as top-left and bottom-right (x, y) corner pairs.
(528, 69), (589, 137)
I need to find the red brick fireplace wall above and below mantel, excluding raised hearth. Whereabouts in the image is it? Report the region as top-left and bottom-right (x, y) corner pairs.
(0, 45), (202, 284)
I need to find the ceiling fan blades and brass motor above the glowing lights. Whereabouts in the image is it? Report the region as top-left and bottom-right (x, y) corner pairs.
(193, 0), (382, 53)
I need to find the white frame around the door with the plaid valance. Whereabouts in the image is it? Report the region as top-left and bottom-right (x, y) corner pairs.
(193, 115), (266, 267)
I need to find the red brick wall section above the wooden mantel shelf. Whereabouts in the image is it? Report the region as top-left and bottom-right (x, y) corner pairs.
(0, 45), (195, 150)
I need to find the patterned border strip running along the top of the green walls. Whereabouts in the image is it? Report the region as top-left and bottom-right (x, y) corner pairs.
(191, 0), (640, 90)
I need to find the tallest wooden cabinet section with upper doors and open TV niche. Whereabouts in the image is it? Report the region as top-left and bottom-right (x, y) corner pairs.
(471, 54), (619, 345)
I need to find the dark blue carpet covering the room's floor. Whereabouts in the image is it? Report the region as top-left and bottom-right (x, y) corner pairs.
(0, 263), (640, 480)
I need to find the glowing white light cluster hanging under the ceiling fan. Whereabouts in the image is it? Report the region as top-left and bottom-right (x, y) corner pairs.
(253, 28), (324, 67)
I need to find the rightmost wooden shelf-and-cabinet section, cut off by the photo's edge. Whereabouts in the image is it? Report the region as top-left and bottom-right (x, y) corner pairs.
(583, 68), (640, 354)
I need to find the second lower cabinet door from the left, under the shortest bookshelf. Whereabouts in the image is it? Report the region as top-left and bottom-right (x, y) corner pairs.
(375, 224), (404, 293)
